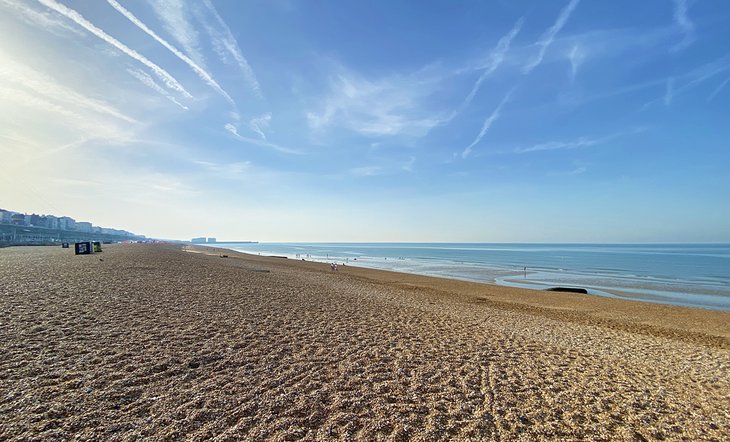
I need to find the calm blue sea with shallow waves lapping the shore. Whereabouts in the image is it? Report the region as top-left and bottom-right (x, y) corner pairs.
(216, 243), (730, 311)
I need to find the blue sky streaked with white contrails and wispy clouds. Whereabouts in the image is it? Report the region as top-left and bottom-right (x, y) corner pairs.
(0, 0), (730, 242)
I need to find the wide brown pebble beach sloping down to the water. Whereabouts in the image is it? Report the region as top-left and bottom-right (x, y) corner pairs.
(0, 244), (730, 441)
